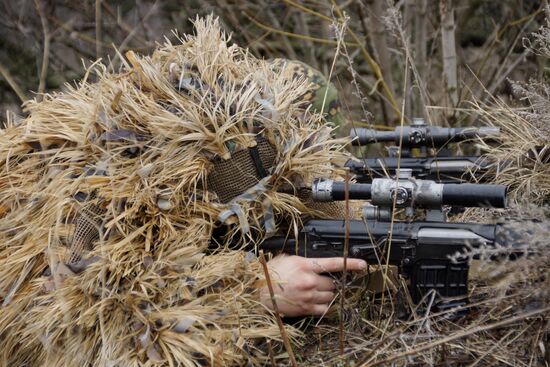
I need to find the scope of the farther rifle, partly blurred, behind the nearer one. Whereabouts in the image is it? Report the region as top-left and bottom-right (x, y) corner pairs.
(350, 125), (500, 148)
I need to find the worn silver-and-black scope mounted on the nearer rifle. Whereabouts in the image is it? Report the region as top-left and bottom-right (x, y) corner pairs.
(312, 178), (507, 208)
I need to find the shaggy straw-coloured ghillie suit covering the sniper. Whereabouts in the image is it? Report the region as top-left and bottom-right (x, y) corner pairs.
(0, 18), (352, 366)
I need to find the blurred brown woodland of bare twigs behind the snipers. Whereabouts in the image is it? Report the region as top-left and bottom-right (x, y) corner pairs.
(0, 0), (548, 129)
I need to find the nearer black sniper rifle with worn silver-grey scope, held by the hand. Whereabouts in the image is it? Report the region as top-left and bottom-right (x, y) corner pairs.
(260, 170), (516, 309)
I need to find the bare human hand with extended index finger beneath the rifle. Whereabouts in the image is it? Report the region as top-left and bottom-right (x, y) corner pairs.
(260, 254), (367, 316)
